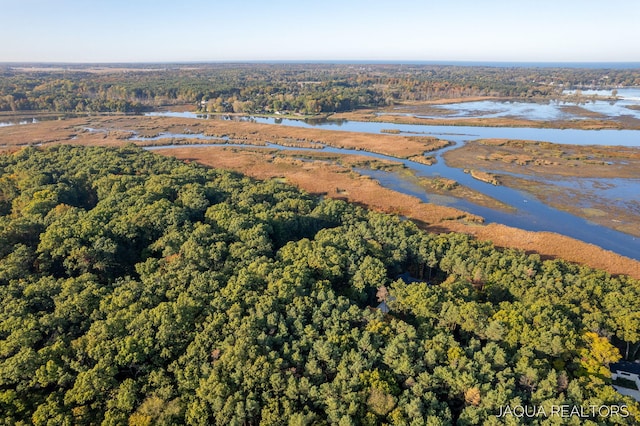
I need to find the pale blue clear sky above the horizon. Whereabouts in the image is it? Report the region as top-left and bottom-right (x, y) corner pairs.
(0, 0), (640, 62)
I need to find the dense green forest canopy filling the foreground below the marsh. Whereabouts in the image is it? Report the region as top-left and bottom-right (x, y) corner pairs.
(0, 146), (640, 425)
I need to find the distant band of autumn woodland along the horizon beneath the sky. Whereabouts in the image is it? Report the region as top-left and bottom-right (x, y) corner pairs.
(0, 64), (640, 114)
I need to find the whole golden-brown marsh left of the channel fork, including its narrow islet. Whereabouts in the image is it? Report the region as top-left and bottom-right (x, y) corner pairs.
(0, 110), (640, 277)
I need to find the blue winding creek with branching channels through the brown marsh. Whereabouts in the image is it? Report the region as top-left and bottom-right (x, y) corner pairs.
(141, 113), (640, 260)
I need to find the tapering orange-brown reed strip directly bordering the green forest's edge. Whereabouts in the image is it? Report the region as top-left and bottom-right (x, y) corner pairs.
(156, 147), (640, 279)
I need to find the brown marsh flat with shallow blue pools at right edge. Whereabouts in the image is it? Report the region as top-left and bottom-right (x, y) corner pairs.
(444, 139), (640, 236)
